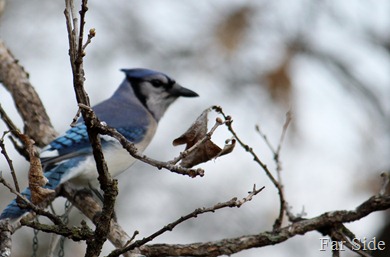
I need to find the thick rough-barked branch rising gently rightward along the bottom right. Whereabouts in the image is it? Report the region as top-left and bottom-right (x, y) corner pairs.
(140, 195), (390, 257)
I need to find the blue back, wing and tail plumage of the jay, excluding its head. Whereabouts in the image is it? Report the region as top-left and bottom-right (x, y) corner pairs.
(0, 83), (151, 219)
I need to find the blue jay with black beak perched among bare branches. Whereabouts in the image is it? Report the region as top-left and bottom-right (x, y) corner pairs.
(0, 69), (198, 219)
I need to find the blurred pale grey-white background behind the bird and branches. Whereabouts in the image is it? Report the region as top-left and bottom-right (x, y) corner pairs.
(0, 0), (390, 257)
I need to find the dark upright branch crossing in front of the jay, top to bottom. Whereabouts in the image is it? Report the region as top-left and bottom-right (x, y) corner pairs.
(64, 0), (118, 256)
